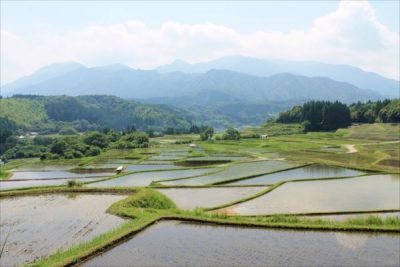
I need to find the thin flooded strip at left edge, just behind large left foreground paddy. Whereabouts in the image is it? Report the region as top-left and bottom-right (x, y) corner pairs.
(0, 178), (103, 190)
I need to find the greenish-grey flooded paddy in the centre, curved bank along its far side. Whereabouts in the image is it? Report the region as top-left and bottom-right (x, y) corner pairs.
(163, 160), (296, 185)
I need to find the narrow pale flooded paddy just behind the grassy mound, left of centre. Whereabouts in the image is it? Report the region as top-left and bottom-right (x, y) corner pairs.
(88, 168), (219, 187)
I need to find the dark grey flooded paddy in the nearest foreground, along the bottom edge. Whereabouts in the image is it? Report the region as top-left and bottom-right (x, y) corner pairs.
(83, 221), (400, 266)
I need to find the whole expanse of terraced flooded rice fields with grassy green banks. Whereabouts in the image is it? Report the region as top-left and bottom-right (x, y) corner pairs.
(0, 124), (400, 266)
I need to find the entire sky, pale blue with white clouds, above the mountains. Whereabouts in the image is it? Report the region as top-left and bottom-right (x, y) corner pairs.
(0, 0), (400, 85)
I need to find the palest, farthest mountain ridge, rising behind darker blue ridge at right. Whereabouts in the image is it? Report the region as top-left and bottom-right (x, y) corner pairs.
(158, 56), (399, 97)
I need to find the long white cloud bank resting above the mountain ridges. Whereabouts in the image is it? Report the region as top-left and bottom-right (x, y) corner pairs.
(1, 1), (399, 83)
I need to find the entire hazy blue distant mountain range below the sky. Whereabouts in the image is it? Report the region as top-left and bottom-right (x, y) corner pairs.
(2, 56), (399, 126)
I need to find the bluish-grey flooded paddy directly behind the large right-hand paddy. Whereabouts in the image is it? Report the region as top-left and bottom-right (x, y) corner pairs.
(231, 164), (363, 185)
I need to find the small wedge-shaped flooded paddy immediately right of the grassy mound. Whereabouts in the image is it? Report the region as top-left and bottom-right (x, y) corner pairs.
(158, 187), (266, 209)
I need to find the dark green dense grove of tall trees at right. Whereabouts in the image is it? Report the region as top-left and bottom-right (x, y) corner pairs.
(276, 99), (400, 131)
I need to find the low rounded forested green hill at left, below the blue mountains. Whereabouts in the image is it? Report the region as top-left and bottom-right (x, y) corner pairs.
(0, 95), (193, 132)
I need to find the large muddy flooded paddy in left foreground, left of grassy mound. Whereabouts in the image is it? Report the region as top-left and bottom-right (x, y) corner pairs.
(0, 194), (125, 266)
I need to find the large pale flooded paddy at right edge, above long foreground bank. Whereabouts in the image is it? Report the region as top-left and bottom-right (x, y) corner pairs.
(220, 175), (400, 215)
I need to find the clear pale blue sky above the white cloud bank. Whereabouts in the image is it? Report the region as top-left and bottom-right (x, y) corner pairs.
(1, 1), (400, 34)
